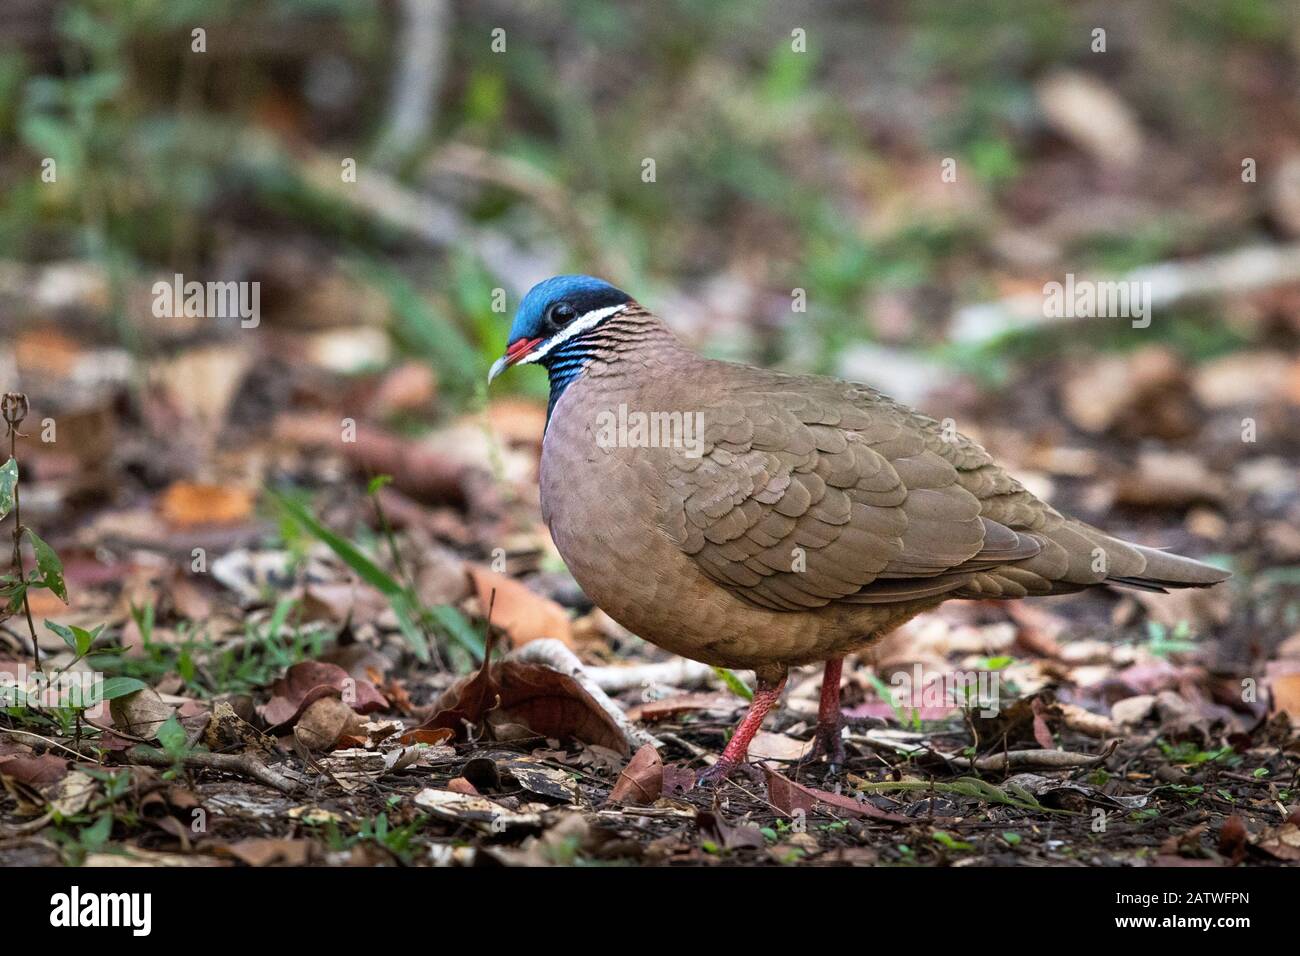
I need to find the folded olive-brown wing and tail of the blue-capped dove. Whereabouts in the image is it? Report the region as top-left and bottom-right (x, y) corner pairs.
(663, 365), (1222, 610)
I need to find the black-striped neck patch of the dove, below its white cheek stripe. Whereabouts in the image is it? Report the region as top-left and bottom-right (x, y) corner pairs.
(546, 303), (690, 421)
